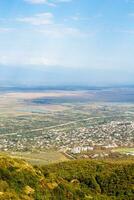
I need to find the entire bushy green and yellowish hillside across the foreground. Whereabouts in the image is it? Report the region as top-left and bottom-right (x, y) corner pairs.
(0, 156), (134, 200)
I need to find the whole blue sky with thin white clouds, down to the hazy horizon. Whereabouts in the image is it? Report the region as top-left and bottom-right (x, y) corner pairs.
(0, 0), (134, 86)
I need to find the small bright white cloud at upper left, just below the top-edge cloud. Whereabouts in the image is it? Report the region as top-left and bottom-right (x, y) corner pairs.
(17, 13), (53, 25)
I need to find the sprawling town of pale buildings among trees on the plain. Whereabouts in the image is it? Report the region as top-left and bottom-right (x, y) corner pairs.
(0, 121), (134, 157)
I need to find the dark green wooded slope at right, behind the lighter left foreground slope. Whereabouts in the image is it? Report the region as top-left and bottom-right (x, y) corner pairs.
(42, 160), (134, 200)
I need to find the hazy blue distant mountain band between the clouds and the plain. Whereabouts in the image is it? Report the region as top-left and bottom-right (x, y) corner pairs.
(0, 65), (134, 87)
